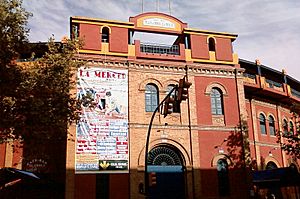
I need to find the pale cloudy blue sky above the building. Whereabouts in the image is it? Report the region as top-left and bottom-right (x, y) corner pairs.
(23, 0), (300, 81)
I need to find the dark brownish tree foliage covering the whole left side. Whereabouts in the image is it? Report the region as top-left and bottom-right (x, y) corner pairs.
(0, 0), (84, 143)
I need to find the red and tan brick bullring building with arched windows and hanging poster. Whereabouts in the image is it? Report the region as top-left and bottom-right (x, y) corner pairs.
(0, 12), (300, 199)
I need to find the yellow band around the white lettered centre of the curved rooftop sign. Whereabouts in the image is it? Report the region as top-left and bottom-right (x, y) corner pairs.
(136, 15), (182, 32)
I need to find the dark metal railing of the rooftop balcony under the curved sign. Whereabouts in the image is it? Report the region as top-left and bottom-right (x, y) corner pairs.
(141, 43), (180, 55)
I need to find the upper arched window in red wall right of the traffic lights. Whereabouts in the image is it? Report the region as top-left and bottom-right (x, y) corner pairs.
(210, 88), (223, 115)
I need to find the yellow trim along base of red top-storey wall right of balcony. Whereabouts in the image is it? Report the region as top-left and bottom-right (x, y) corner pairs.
(185, 49), (239, 64)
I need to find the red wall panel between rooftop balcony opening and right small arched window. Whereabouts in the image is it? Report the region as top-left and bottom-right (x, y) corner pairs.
(191, 35), (209, 59)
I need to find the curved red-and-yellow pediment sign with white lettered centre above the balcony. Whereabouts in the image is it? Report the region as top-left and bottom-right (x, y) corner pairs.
(129, 12), (187, 34)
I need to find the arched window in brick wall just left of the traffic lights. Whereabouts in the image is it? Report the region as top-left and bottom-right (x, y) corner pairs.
(145, 84), (158, 112)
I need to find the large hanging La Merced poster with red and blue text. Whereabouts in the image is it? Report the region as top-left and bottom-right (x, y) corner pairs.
(75, 67), (128, 173)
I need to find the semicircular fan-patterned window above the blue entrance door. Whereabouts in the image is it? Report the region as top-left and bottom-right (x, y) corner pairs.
(148, 146), (182, 166)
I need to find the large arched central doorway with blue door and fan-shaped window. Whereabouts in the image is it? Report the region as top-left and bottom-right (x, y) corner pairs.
(147, 145), (185, 199)
